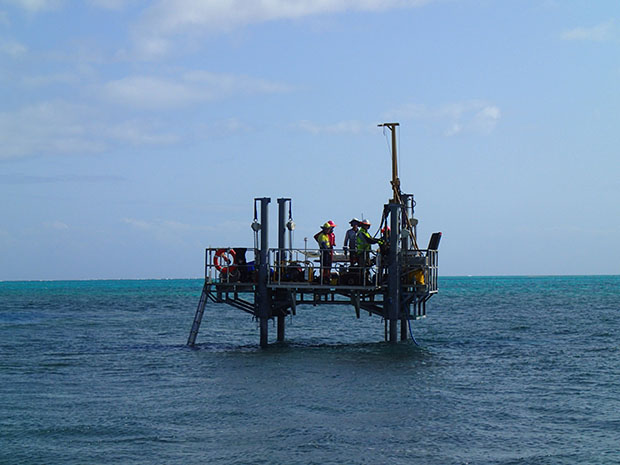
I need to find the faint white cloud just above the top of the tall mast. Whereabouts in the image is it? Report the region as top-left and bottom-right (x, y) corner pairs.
(385, 100), (501, 137)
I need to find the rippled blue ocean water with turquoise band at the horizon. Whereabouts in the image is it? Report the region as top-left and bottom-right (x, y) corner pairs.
(0, 276), (620, 464)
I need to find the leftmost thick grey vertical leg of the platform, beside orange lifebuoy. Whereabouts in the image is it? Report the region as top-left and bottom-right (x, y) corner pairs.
(255, 197), (271, 347)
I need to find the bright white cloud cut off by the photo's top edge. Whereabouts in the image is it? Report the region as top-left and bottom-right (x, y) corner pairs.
(137, 0), (433, 57)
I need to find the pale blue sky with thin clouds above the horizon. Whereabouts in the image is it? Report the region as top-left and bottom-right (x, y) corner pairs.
(0, 0), (620, 280)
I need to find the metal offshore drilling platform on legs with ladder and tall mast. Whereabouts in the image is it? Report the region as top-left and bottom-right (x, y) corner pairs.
(187, 123), (441, 347)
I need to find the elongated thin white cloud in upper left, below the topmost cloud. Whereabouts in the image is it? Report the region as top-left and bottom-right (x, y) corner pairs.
(105, 71), (290, 108)
